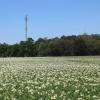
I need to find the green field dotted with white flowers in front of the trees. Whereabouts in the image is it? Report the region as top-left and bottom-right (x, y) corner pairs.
(0, 57), (100, 100)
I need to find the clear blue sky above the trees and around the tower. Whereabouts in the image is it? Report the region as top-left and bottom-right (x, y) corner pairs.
(0, 0), (100, 44)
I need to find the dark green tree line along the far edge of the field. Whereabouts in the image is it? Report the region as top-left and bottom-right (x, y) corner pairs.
(0, 34), (100, 57)
